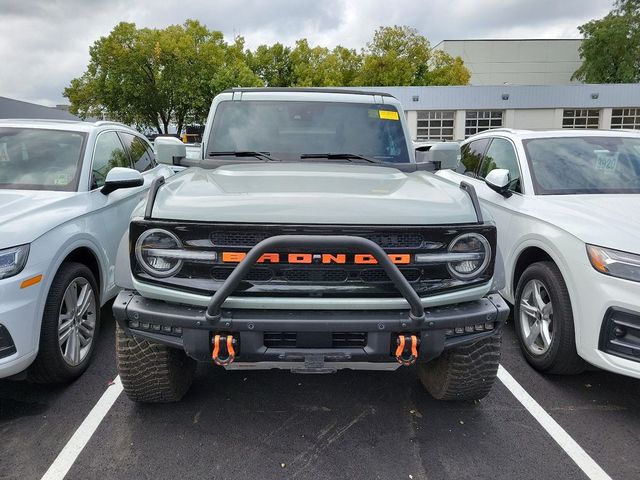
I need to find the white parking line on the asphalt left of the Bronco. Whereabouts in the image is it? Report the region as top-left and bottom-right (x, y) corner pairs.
(42, 376), (122, 480)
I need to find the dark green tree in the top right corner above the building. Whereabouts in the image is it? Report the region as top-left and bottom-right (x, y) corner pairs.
(572, 0), (640, 83)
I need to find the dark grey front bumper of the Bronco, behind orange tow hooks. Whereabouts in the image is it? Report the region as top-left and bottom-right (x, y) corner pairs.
(113, 290), (509, 364)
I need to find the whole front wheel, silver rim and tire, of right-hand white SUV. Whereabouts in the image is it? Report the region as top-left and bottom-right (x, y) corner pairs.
(514, 262), (585, 375)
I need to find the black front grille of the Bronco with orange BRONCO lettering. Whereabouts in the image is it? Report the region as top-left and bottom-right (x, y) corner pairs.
(130, 220), (496, 298)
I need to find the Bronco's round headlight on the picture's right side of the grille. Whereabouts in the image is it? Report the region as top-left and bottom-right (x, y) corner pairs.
(447, 233), (491, 281)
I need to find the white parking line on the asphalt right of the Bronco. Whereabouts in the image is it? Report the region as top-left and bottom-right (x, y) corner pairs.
(498, 365), (611, 480)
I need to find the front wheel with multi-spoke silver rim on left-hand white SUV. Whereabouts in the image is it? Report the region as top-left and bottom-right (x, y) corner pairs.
(28, 262), (100, 383)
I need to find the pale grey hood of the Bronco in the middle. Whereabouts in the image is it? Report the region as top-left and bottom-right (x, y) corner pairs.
(152, 162), (476, 225)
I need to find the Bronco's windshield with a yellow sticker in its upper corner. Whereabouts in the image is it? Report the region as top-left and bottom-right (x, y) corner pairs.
(207, 100), (410, 163)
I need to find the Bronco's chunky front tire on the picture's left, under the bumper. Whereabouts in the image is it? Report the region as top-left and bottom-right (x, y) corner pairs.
(116, 325), (196, 403)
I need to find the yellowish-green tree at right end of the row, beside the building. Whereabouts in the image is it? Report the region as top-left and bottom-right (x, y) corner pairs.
(358, 25), (470, 86)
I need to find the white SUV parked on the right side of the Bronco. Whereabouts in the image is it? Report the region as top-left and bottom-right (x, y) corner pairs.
(437, 129), (640, 378)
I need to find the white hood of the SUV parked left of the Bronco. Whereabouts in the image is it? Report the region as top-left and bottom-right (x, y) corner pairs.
(0, 190), (82, 249)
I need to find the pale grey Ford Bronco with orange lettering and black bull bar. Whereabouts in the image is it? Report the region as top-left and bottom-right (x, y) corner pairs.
(114, 89), (508, 402)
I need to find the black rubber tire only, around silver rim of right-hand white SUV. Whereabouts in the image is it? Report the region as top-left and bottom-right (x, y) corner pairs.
(513, 262), (585, 375)
